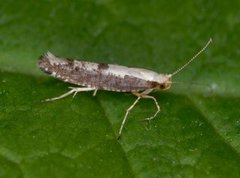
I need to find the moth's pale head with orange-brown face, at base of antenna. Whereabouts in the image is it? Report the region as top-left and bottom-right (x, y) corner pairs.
(153, 74), (172, 90)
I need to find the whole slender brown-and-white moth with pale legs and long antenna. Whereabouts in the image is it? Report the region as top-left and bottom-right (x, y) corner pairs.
(38, 39), (212, 138)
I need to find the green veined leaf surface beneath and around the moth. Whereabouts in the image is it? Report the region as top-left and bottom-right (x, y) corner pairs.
(0, 0), (240, 178)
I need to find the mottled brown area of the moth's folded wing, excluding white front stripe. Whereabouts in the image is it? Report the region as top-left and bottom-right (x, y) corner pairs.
(39, 53), (153, 92)
